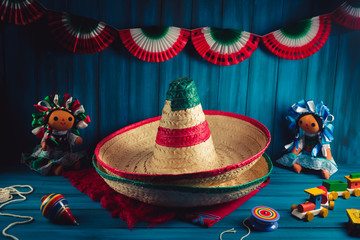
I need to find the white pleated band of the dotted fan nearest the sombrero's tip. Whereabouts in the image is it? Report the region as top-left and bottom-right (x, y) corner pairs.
(201, 27), (250, 54)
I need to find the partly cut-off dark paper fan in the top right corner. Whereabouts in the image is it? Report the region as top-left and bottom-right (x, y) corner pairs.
(331, 0), (360, 30)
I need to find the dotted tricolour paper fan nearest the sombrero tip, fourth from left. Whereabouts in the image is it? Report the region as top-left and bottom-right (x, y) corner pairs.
(191, 27), (260, 65)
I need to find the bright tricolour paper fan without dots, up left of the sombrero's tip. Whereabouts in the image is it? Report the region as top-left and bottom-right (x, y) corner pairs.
(119, 27), (190, 62)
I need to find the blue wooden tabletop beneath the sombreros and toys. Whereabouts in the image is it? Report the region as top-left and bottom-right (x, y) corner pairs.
(0, 166), (360, 240)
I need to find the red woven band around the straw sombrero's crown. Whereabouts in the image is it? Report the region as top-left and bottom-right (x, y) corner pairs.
(156, 120), (210, 148)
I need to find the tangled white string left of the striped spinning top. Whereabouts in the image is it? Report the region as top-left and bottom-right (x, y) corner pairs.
(0, 185), (34, 240)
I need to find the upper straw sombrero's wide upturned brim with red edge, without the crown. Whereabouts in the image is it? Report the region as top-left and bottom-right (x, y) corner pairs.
(95, 111), (270, 185)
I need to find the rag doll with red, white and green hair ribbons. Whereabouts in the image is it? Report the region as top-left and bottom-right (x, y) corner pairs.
(23, 94), (90, 175)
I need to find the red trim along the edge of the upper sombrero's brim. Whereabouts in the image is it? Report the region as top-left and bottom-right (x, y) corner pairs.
(95, 110), (271, 182)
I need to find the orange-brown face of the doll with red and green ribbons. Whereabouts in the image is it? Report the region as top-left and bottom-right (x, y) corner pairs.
(48, 110), (75, 131)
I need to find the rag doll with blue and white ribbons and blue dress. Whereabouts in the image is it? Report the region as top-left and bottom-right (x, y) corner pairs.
(277, 100), (338, 179)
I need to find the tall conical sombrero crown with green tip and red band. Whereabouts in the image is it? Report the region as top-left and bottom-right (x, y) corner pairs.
(148, 78), (220, 174)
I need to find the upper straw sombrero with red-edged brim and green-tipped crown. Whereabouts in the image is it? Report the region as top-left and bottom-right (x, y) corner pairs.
(95, 78), (272, 206)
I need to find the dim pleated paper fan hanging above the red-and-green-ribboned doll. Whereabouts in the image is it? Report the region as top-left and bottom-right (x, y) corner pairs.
(48, 11), (116, 53)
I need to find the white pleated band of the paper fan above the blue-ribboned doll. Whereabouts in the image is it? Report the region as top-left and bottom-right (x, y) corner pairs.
(273, 17), (320, 47)
